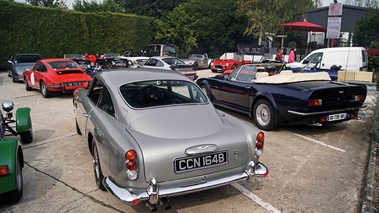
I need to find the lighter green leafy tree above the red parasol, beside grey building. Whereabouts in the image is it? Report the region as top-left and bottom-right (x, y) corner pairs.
(237, 0), (321, 44)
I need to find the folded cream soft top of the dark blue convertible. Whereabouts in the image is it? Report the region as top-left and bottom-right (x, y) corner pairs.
(253, 70), (331, 84)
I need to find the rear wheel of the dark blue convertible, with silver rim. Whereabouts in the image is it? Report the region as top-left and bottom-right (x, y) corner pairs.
(253, 99), (275, 131)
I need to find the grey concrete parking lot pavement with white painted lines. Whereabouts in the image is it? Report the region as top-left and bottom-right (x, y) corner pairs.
(0, 70), (370, 213)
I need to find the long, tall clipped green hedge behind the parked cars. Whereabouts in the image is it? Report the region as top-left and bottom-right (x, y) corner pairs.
(0, 1), (154, 67)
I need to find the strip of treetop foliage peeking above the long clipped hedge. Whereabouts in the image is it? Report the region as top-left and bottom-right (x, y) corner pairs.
(72, 0), (125, 13)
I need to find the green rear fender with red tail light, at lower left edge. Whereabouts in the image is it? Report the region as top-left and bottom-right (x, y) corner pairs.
(0, 139), (24, 196)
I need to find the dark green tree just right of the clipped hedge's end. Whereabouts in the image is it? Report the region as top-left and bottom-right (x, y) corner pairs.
(156, 0), (246, 57)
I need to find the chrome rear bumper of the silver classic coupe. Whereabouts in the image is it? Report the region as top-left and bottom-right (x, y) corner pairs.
(103, 161), (268, 205)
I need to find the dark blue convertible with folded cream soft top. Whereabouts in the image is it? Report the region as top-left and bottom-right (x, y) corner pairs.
(197, 64), (367, 130)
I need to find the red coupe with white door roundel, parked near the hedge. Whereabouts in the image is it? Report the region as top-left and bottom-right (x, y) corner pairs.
(23, 58), (92, 98)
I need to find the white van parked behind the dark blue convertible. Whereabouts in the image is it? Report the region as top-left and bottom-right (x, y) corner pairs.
(286, 47), (368, 71)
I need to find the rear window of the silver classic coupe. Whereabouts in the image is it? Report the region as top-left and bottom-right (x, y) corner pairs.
(120, 80), (208, 108)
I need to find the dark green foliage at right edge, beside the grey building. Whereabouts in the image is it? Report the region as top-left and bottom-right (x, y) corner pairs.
(353, 10), (379, 47)
